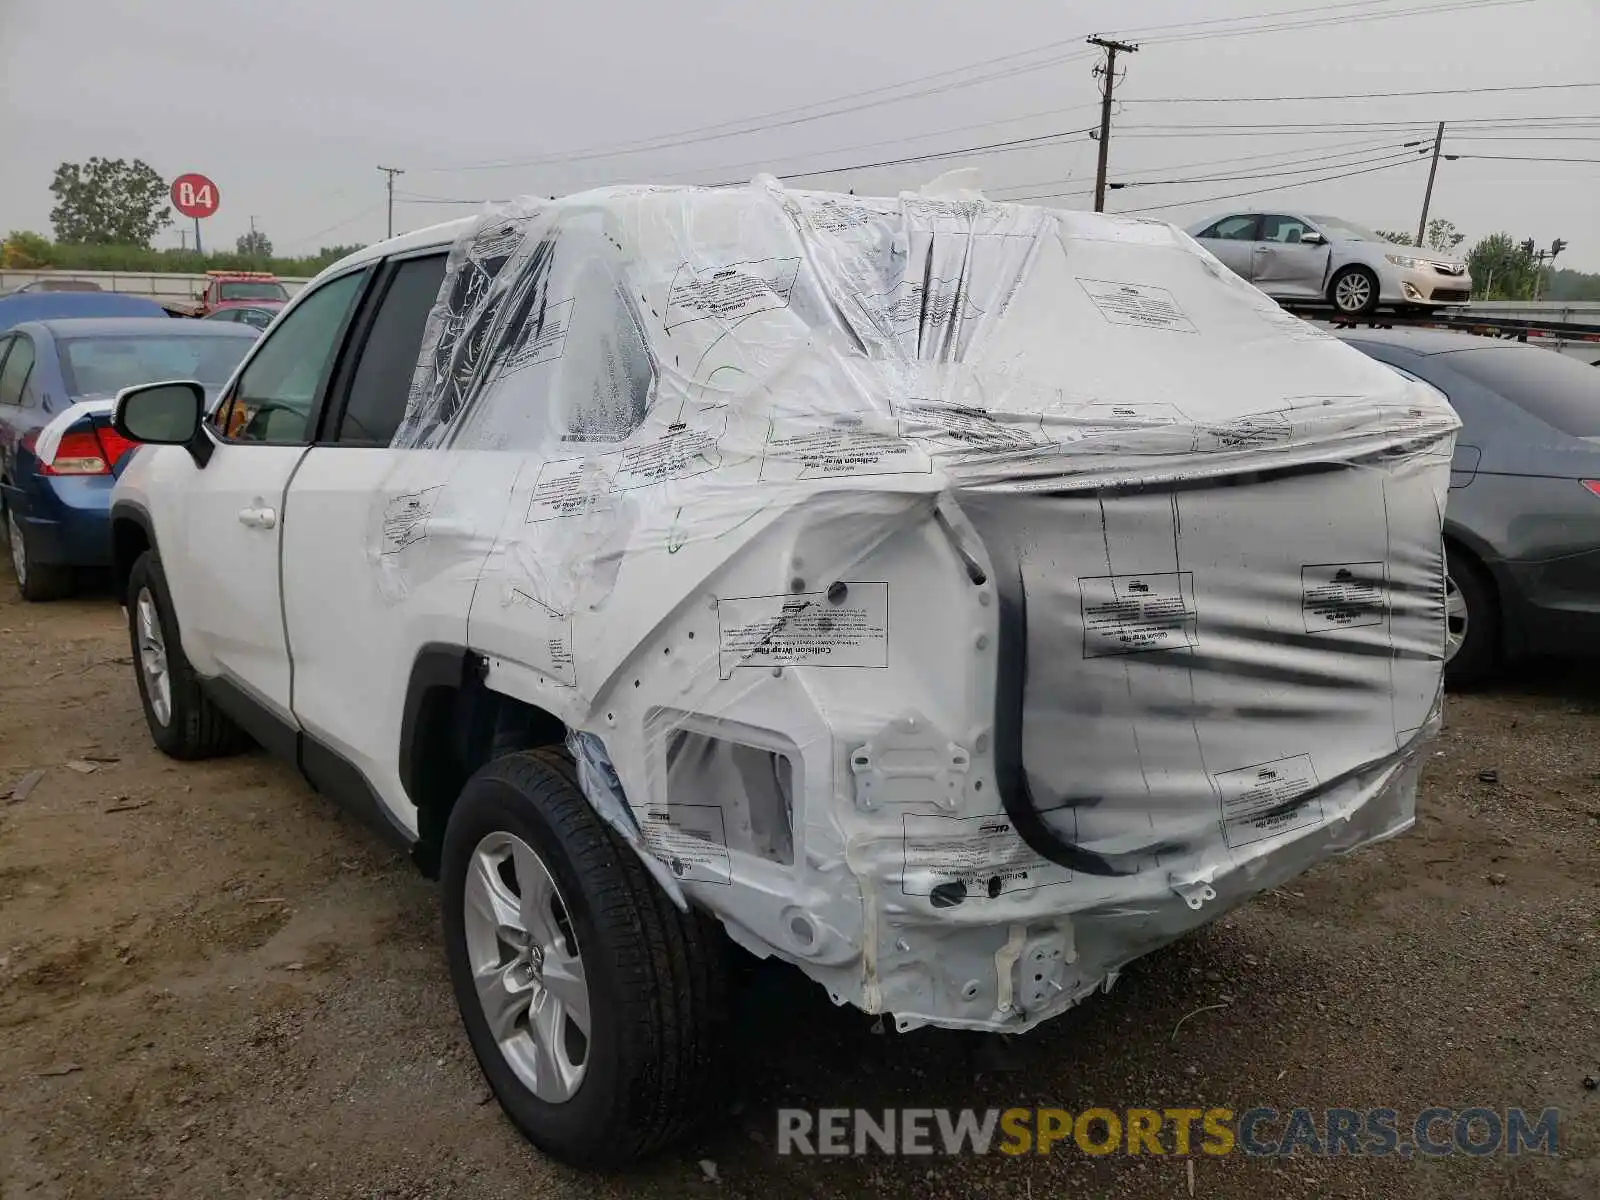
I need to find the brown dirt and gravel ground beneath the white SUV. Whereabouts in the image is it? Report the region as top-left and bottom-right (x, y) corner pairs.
(0, 579), (1600, 1200)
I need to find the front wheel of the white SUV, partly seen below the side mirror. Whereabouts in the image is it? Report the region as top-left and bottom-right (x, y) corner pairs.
(126, 550), (250, 758)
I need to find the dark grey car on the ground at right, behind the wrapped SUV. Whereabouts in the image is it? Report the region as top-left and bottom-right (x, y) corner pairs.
(1344, 330), (1600, 683)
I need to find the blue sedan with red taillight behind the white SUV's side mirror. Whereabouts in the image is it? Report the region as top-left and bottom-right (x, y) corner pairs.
(0, 320), (256, 600)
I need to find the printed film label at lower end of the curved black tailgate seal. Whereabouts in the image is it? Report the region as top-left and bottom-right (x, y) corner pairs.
(901, 814), (1072, 899)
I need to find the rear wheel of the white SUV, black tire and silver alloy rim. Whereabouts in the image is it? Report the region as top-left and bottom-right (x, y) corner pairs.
(440, 750), (726, 1166)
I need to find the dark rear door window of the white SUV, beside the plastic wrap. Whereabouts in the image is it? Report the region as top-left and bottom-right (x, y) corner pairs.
(334, 254), (445, 446)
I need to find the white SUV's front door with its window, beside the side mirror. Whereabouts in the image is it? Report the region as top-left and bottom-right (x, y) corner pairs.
(169, 269), (368, 722)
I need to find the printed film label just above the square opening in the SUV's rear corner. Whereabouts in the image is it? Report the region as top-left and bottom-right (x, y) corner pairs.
(717, 584), (890, 678)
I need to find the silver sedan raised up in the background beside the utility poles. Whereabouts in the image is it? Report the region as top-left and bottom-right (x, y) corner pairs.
(1189, 210), (1472, 317)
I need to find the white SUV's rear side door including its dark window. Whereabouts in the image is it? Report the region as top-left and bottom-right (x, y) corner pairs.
(280, 246), (467, 829)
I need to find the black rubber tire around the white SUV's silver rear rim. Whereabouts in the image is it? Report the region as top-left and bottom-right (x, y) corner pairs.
(440, 750), (726, 1166)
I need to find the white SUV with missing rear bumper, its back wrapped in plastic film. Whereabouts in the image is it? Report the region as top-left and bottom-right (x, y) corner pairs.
(114, 179), (1458, 1163)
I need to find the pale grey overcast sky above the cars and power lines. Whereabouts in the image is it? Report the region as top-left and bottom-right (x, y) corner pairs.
(0, 0), (1600, 270)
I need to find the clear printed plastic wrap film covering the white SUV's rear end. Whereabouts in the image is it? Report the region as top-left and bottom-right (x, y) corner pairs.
(371, 178), (1458, 1030)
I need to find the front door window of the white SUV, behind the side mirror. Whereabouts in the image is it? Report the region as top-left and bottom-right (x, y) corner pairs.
(216, 270), (366, 445)
